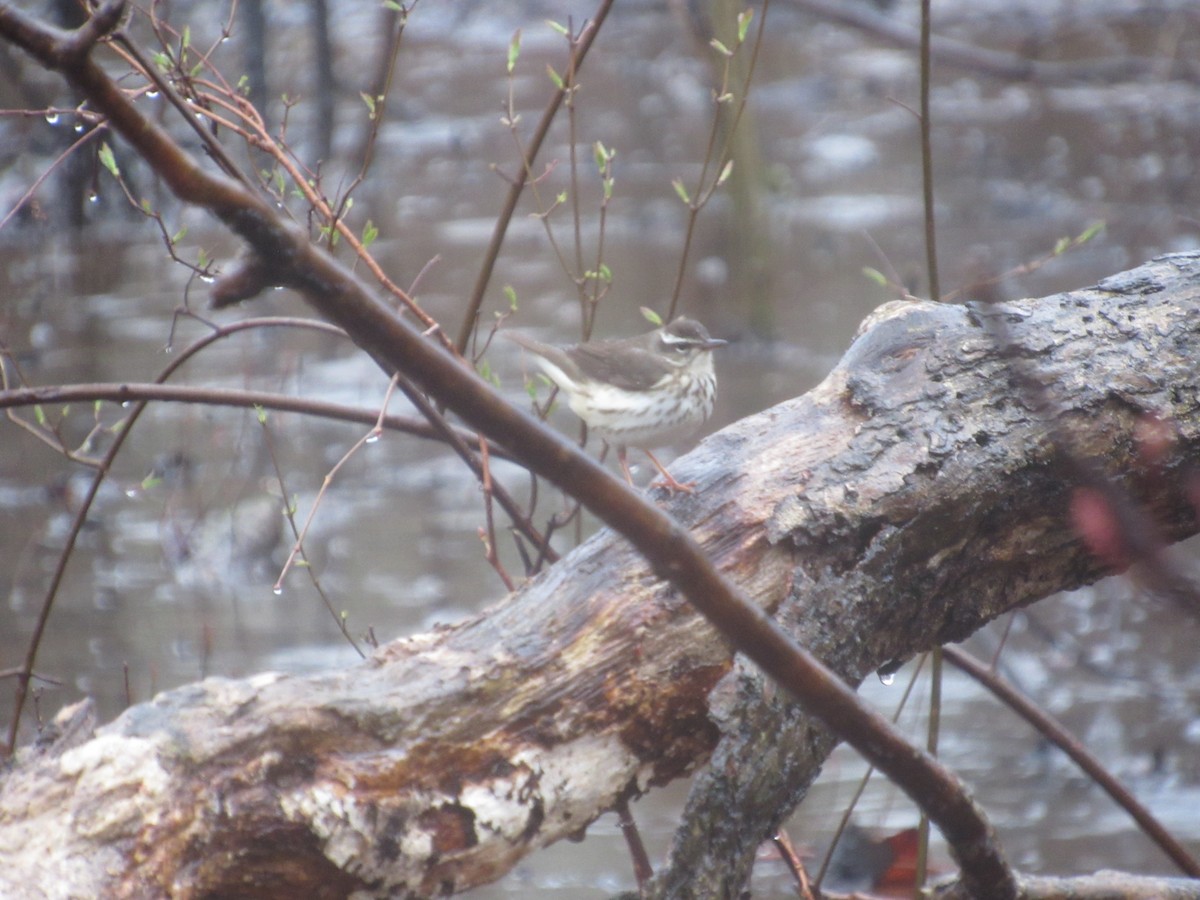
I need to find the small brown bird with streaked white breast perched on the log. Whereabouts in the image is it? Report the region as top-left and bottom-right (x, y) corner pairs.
(503, 316), (726, 493)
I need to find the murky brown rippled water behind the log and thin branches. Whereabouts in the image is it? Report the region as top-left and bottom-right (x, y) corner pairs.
(0, 5), (1200, 898)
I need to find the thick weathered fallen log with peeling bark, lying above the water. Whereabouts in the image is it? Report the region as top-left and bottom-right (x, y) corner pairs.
(7, 254), (1200, 898)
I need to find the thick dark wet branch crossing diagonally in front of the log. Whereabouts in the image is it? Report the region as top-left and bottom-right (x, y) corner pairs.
(0, 0), (1018, 900)
